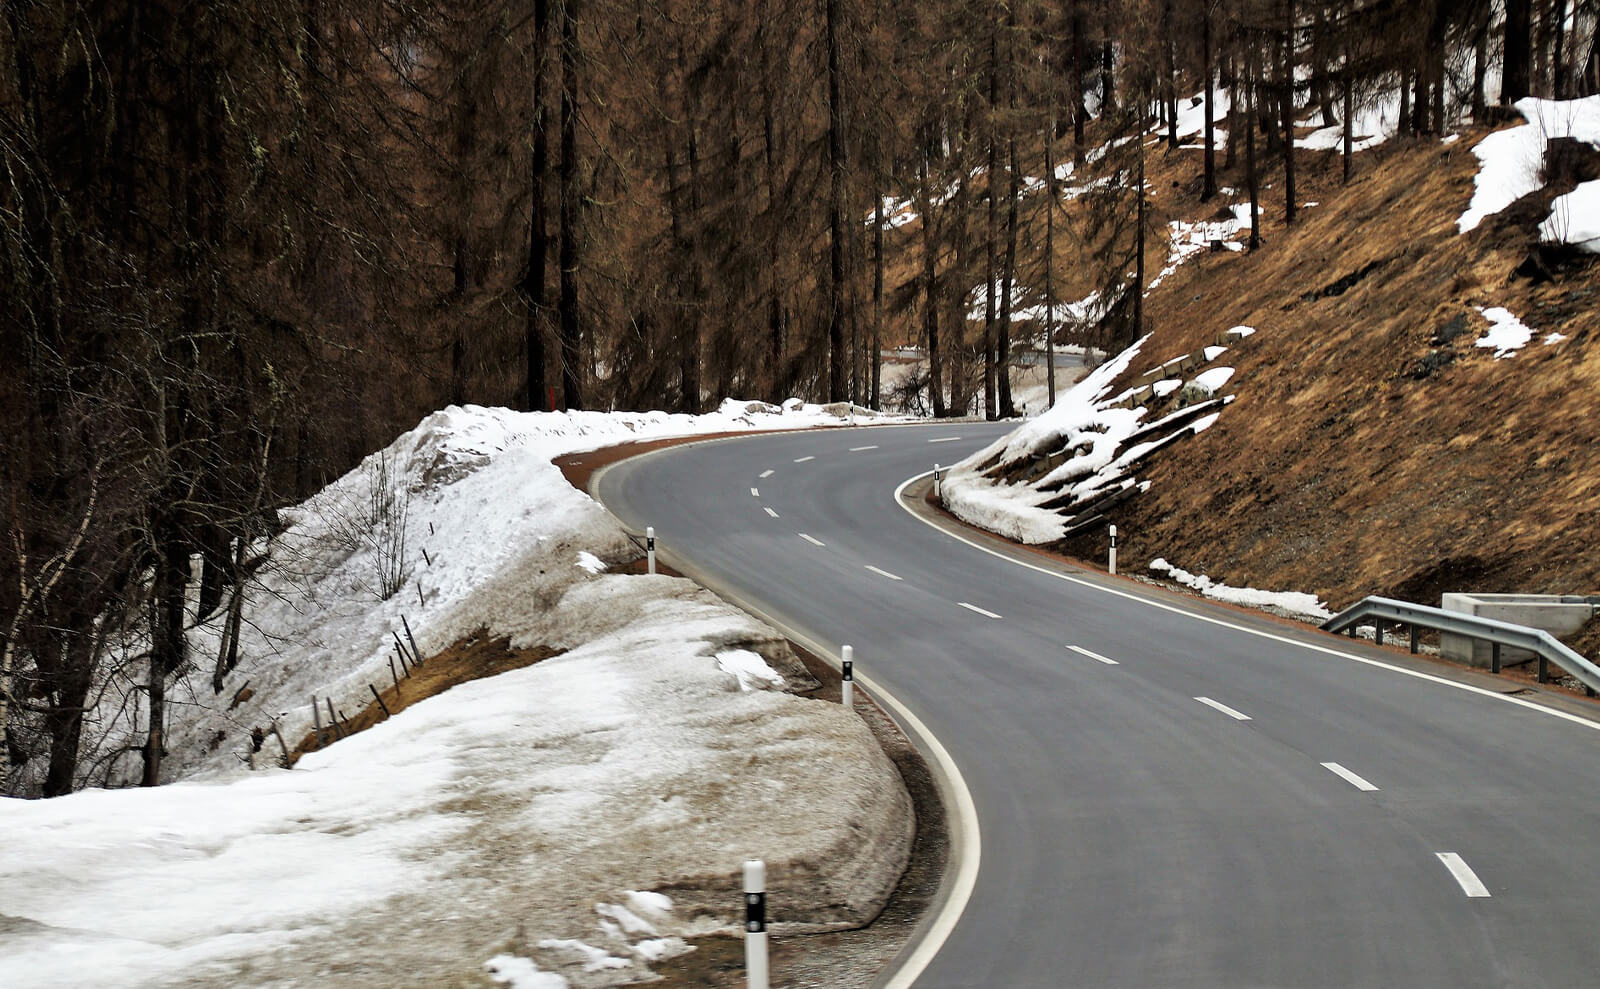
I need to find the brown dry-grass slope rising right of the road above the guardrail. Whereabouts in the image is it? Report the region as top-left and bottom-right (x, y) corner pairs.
(1061, 131), (1600, 608)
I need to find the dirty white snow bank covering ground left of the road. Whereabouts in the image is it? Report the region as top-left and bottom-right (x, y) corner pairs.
(0, 396), (910, 987)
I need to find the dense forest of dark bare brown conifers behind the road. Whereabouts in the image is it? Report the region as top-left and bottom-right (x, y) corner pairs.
(9, 0), (1600, 794)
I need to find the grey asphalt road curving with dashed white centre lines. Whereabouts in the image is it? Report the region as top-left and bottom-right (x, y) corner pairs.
(598, 424), (1600, 989)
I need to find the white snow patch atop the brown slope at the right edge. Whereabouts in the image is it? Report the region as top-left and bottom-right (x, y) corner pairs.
(1456, 96), (1600, 236)
